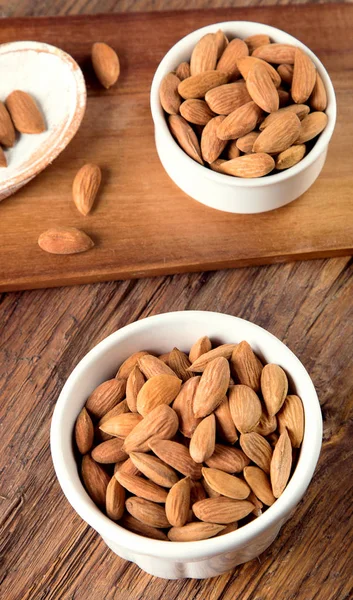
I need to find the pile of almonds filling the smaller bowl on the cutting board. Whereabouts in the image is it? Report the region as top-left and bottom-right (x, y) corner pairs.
(159, 30), (327, 178)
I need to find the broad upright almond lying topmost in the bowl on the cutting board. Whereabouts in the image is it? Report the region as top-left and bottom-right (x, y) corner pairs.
(246, 63), (279, 113)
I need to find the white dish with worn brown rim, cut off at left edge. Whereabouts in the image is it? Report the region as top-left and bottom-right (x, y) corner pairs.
(0, 41), (86, 200)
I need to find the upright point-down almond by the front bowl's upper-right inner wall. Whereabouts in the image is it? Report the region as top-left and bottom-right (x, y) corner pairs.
(261, 364), (288, 416)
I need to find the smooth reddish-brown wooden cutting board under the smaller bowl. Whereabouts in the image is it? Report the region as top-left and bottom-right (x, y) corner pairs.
(0, 4), (353, 290)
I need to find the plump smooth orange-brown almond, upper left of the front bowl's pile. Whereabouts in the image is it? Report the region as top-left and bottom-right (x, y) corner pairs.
(136, 372), (182, 417)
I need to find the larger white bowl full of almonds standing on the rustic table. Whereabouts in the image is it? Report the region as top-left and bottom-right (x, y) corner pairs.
(51, 311), (322, 579)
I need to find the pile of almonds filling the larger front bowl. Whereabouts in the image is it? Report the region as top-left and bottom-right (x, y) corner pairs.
(75, 337), (304, 542)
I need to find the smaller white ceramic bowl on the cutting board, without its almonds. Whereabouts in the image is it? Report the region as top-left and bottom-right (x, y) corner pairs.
(151, 21), (336, 213)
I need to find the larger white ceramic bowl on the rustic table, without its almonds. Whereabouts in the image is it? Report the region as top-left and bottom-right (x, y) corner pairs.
(51, 311), (322, 579)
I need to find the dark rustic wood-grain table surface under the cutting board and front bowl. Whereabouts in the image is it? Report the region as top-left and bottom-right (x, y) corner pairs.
(0, 0), (353, 600)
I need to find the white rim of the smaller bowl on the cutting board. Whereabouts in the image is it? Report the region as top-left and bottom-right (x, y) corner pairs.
(150, 21), (337, 188)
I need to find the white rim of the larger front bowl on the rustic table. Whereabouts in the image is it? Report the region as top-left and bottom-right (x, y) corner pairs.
(50, 311), (322, 561)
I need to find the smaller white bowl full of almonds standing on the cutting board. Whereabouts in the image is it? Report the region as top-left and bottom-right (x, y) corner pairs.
(151, 21), (336, 213)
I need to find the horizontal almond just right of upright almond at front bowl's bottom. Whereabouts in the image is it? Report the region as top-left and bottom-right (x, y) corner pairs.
(192, 497), (254, 525)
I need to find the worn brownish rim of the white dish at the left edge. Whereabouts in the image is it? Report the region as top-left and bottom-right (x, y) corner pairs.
(0, 40), (87, 193)
